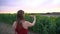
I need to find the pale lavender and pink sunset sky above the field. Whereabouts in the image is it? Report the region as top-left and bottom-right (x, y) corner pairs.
(0, 0), (60, 13)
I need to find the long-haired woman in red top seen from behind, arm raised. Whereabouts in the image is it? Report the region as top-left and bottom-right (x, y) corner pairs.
(13, 10), (36, 34)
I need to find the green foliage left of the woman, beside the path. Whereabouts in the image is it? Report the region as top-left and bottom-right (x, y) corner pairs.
(0, 14), (16, 25)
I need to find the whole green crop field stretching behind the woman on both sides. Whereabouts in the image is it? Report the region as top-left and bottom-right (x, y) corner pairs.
(0, 14), (60, 34)
